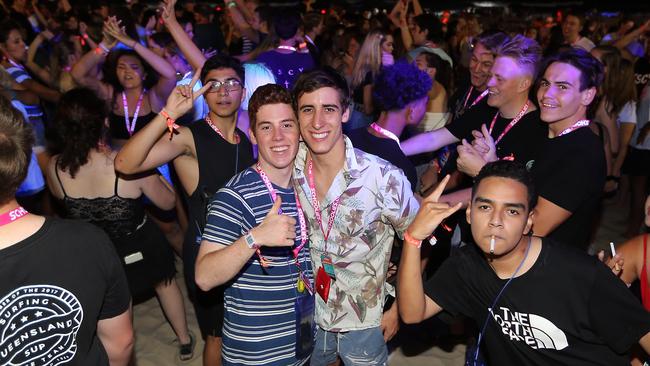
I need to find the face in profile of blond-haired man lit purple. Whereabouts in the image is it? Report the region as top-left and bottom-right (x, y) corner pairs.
(487, 57), (529, 108)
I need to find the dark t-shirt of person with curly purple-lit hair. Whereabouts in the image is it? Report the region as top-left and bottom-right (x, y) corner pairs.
(347, 127), (418, 191)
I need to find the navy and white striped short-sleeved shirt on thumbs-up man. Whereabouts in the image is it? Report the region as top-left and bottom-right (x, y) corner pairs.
(203, 168), (313, 366)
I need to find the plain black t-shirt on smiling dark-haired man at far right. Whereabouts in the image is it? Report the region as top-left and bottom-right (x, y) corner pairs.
(532, 128), (607, 250)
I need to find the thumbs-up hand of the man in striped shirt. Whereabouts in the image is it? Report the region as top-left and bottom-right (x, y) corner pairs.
(252, 196), (296, 247)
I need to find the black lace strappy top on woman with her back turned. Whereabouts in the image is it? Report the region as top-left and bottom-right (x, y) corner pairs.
(55, 161), (144, 239)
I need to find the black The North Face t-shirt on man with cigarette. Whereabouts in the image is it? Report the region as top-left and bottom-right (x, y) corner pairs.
(425, 239), (650, 366)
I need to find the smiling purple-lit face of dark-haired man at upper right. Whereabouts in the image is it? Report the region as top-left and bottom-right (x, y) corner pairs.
(537, 62), (596, 127)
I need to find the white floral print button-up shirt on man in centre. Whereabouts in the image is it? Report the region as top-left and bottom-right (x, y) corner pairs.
(293, 137), (419, 331)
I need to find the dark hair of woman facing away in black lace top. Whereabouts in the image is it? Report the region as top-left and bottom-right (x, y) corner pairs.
(54, 88), (108, 178)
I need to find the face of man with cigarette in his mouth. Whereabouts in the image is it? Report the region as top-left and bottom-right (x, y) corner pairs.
(466, 177), (533, 258)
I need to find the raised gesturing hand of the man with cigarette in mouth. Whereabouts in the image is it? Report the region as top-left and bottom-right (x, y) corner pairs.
(407, 175), (462, 240)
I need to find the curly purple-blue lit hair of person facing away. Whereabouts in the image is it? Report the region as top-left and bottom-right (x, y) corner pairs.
(372, 61), (432, 111)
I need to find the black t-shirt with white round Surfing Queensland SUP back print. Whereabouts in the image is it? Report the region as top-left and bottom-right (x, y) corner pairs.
(0, 219), (131, 365)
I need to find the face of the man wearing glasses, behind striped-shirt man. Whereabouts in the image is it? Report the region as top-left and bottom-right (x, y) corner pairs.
(203, 68), (246, 118)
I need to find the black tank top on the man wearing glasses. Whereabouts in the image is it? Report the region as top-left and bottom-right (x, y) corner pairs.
(182, 120), (255, 243)
